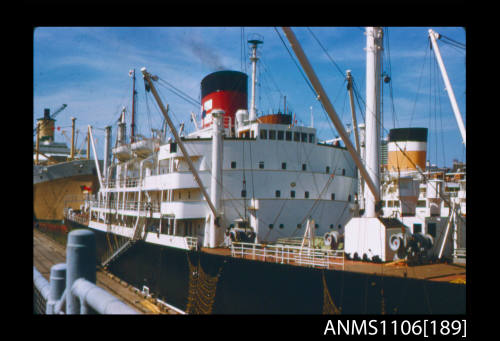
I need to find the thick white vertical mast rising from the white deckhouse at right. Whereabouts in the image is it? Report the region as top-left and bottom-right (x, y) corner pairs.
(364, 27), (383, 218)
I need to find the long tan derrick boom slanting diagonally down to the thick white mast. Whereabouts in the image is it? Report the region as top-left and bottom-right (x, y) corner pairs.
(282, 27), (380, 201)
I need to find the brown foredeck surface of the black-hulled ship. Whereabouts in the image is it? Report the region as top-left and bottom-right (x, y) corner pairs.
(202, 248), (466, 284)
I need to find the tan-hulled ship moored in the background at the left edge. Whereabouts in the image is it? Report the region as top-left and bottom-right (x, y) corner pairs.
(33, 104), (102, 232)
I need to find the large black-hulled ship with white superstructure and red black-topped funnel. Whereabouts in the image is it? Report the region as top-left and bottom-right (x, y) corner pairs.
(65, 28), (466, 314)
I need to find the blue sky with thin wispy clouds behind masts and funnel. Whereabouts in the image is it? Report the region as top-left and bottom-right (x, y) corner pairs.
(33, 27), (466, 166)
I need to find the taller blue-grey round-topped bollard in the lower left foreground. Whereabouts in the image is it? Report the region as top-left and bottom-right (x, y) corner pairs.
(66, 230), (96, 314)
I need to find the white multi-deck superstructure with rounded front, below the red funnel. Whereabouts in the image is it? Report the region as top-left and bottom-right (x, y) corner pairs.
(89, 113), (357, 246)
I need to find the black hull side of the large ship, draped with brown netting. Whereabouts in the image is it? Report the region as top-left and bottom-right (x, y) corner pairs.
(84, 230), (466, 315)
